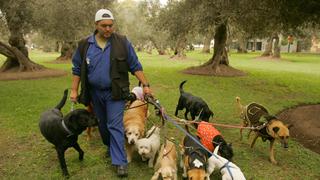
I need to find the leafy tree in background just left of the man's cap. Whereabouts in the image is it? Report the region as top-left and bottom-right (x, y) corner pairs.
(34, 0), (104, 60)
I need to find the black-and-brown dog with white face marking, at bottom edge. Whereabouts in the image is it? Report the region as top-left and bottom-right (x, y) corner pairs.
(180, 136), (209, 180)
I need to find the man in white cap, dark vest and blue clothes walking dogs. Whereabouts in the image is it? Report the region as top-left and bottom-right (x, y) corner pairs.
(70, 9), (151, 177)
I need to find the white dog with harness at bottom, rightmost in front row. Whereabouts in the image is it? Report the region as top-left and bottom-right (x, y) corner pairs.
(207, 146), (246, 180)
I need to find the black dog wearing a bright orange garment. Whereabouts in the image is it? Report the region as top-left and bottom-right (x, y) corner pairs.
(197, 121), (233, 161)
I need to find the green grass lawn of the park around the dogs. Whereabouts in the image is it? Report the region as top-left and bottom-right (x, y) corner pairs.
(0, 51), (320, 180)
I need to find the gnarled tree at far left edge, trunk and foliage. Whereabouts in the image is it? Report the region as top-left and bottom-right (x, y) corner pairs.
(0, 0), (44, 72)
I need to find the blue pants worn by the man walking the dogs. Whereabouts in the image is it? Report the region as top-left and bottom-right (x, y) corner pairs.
(91, 89), (128, 165)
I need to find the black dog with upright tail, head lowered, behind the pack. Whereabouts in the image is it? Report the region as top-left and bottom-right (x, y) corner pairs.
(174, 81), (213, 122)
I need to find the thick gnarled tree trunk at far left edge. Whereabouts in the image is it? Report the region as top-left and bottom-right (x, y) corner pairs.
(0, 41), (45, 72)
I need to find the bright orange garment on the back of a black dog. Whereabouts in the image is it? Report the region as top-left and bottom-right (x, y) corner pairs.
(197, 121), (221, 152)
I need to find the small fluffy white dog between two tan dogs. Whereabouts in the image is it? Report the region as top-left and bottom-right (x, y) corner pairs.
(136, 126), (160, 168)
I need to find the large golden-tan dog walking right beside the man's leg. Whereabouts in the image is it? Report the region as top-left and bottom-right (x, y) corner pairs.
(123, 100), (148, 162)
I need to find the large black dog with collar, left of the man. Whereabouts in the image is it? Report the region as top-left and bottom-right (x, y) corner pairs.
(39, 90), (97, 176)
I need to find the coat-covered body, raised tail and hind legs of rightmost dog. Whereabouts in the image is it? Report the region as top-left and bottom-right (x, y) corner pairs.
(236, 97), (269, 140)
